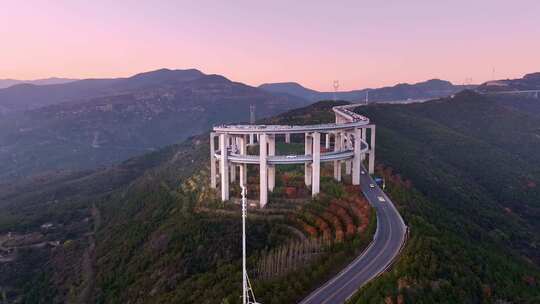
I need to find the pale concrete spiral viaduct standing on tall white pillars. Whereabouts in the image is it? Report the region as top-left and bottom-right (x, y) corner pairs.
(210, 104), (375, 208)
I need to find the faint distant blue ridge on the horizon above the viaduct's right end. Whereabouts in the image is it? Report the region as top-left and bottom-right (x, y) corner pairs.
(259, 79), (468, 102)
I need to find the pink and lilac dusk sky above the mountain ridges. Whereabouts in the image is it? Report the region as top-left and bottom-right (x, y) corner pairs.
(0, 0), (540, 91)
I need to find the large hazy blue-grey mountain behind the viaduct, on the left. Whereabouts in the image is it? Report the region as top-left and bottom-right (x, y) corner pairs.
(0, 69), (309, 179)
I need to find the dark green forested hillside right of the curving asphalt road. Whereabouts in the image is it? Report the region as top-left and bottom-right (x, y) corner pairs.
(352, 92), (540, 303)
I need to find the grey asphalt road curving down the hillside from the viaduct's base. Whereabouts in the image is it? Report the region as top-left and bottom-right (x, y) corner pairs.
(300, 168), (407, 304)
